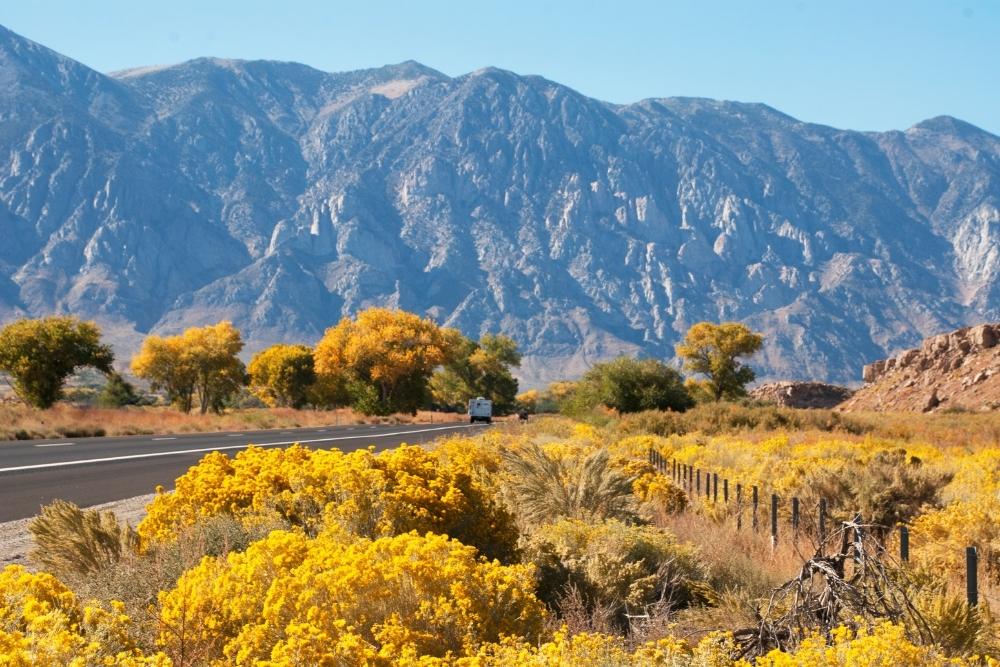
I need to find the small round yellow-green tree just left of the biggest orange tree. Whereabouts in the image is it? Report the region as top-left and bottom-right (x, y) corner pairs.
(247, 345), (316, 409)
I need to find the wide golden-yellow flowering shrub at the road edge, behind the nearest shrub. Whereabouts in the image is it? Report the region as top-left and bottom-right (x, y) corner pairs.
(138, 445), (517, 562)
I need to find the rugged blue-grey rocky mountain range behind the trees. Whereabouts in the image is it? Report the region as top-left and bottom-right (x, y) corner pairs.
(0, 24), (1000, 384)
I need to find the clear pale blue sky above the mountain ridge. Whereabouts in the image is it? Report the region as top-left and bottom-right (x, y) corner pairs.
(0, 0), (1000, 134)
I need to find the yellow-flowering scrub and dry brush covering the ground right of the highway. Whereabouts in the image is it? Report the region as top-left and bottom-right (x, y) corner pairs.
(7, 412), (1000, 666)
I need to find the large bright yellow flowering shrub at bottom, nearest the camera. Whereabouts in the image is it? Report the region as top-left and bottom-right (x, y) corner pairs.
(159, 530), (545, 665)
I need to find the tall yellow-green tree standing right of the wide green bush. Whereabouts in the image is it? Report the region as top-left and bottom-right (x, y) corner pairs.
(677, 322), (764, 401)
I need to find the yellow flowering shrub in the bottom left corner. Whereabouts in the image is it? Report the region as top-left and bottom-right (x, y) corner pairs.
(0, 565), (170, 667)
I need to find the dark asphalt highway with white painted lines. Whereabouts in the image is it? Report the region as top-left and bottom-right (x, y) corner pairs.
(0, 422), (479, 521)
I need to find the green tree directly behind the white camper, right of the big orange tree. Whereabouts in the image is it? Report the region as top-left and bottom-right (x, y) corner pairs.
(431, 334), (521, 414)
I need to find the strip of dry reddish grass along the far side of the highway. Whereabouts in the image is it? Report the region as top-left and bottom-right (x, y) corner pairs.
(0, 404), (461, 440)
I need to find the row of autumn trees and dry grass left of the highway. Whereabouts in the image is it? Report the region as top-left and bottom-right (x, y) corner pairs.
(0, 308), (520, 440)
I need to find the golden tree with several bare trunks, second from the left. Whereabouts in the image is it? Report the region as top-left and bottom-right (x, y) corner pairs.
(132, 321), (246, 414)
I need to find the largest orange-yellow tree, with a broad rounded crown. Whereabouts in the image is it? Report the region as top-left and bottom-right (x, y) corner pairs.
(315, 308), (461, 414)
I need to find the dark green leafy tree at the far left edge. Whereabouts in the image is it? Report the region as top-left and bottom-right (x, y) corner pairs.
(0, 316), (114, 409)
